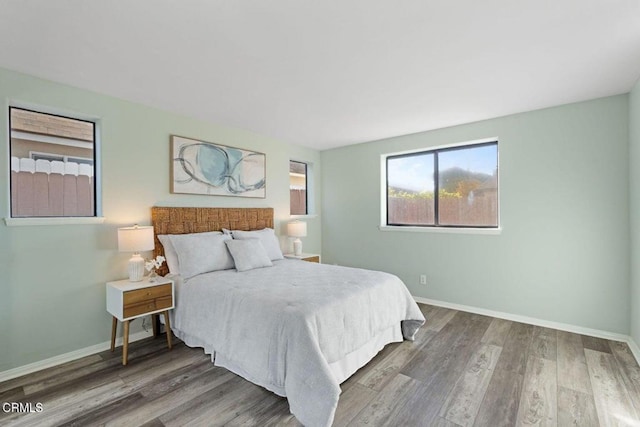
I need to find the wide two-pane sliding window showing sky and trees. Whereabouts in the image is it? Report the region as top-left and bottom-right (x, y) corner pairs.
(385, 141), (499, 228)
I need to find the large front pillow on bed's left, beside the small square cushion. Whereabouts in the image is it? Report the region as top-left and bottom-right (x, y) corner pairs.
(170, 232), (234, 279)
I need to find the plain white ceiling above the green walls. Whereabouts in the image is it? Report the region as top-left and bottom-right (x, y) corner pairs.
(0, 0), (640, 150)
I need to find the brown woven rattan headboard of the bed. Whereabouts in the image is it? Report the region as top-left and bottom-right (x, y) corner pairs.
(151, 206), (273, 276)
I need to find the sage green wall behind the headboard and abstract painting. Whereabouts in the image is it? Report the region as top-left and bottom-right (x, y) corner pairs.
(0, 69), (321, 372)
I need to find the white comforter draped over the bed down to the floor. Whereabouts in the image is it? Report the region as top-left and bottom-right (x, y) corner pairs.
(172, 259), (424, 427)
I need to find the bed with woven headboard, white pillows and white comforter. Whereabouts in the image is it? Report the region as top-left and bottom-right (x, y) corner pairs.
(152, 207), (425, 427)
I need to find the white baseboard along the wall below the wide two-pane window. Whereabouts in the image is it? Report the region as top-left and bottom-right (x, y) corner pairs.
(413, 296), (640, 344)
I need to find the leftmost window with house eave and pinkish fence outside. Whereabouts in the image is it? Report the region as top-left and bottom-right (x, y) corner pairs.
(9, 107), (97, 218)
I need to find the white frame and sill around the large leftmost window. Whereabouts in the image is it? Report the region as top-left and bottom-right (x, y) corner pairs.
(4, 105), (105, 226)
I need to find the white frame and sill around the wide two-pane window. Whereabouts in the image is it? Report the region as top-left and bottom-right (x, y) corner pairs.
(379, 137), (502, 234)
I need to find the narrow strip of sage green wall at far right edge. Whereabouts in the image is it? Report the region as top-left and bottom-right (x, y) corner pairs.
(629, 81), (640, 344)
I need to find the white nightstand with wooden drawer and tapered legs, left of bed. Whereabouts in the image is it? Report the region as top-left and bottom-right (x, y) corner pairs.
(107, 277), (175, 365)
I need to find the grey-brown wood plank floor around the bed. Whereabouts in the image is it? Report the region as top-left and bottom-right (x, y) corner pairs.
(0, 304), (640, 427)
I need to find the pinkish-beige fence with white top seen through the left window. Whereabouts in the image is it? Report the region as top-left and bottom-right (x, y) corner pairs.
(11, 157), (95, 218)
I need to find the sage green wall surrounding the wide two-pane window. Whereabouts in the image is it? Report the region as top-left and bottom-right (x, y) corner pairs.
(321, 95), (630, 334)
